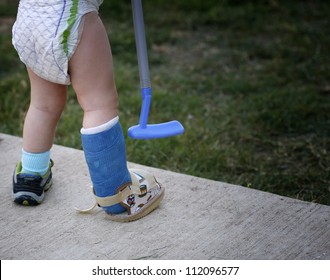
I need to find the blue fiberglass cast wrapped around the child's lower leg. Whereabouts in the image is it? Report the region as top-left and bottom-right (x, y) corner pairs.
(81, 122), (132, 214)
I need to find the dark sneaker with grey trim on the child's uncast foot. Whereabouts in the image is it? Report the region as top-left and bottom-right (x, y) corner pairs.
(13, 160), (54, 206)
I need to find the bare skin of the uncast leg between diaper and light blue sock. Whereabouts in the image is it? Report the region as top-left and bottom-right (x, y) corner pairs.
(23, 69), (67, 153)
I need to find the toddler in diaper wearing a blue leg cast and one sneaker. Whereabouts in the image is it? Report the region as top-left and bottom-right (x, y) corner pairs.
(13, 0), (164, 222)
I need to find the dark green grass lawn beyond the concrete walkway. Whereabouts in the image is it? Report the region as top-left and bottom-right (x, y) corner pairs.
(0, 0), (330, 205)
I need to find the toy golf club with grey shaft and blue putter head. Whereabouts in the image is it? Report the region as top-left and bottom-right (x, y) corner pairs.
(128, 0), (184, 139)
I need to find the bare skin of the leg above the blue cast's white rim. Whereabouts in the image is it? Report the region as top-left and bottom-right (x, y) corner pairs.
(69, 13), (118, 128)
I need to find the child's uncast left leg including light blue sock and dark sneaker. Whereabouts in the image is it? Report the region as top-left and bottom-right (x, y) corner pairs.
(13, 69), (67, 205)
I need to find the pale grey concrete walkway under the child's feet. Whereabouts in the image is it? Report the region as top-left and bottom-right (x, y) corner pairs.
(0, 134), (330, 260)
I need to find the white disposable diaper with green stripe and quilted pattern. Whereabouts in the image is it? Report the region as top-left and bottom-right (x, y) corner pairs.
(12, 0), (103, 85)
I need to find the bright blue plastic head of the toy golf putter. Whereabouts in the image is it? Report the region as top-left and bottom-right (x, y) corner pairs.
(128, 121), (184, 140)
